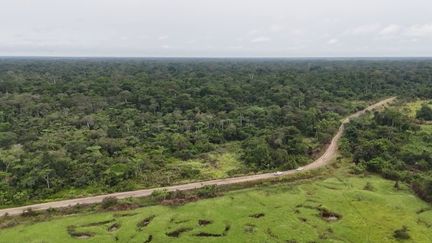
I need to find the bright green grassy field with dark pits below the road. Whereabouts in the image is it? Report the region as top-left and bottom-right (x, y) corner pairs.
(0, 173), (432, 242)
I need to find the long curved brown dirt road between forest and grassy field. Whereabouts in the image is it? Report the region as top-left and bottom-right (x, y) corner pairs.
(0, 97), (396, 216)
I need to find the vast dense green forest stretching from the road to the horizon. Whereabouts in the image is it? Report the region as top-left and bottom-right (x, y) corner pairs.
(0, 59), (432, 205)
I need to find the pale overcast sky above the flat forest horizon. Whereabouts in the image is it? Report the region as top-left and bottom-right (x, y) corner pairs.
(0, 0), (432, 57)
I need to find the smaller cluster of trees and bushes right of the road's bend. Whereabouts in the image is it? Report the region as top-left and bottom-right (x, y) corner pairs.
(342, 105), (432, 202)
